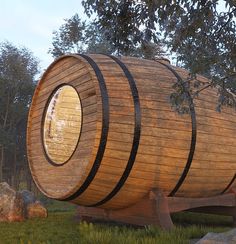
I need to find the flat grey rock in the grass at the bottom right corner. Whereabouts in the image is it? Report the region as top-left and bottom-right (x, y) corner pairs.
(196, 229), (236, 244)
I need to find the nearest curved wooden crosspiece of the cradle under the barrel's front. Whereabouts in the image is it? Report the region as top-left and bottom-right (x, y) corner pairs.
(78, 190), (174, 230)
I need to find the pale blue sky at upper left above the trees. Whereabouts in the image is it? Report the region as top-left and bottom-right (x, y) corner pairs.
(0, 0), (87, 70)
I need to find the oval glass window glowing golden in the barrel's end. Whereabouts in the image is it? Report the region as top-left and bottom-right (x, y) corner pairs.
(43, 85), (82, 165)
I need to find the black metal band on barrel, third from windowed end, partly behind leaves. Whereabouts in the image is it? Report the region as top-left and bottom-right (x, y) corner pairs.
(157, 61), (197, 197)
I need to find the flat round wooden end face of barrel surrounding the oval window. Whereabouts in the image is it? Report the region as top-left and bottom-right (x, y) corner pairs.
(27, 57), (100, 199)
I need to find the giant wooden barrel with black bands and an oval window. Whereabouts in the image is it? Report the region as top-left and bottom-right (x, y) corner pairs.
(27, 54), (236, 209)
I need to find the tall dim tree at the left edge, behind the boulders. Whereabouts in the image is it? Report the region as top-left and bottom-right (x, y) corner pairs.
(0, 42), (38, 186)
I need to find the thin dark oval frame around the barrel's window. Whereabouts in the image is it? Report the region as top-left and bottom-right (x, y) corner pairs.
(40, 83), (83, 167)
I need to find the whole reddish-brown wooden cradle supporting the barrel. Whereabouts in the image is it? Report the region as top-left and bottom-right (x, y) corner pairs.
(78, 190), (236, 230)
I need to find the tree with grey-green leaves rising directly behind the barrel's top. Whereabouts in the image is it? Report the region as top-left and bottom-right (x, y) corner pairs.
(49, 14), (163, 58)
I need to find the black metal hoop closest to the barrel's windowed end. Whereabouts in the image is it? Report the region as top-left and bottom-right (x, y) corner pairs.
(63, 54), (109, 201)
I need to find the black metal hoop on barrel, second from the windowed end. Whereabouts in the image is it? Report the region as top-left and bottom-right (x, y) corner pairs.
(90, 55), (141, 207)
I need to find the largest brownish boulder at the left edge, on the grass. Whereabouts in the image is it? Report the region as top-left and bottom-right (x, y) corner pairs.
(0, 182), (25, 222)
